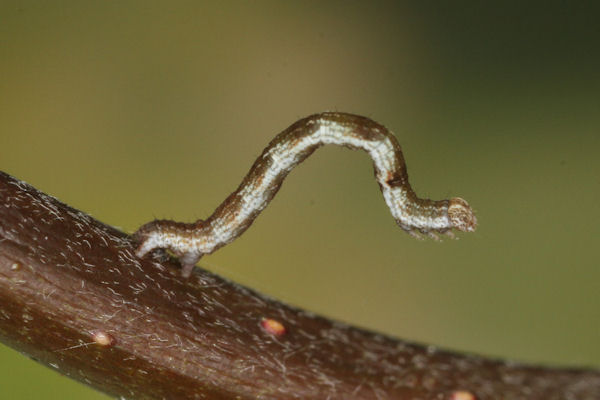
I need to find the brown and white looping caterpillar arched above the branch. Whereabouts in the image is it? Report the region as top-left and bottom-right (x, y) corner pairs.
(134, 112), (477, 277)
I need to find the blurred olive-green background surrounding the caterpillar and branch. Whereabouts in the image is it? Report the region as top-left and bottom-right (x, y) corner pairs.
(0, 1), (600, 399)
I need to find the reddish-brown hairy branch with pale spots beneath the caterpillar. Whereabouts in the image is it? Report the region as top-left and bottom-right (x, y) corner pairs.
(0, 172), (600, 400)
